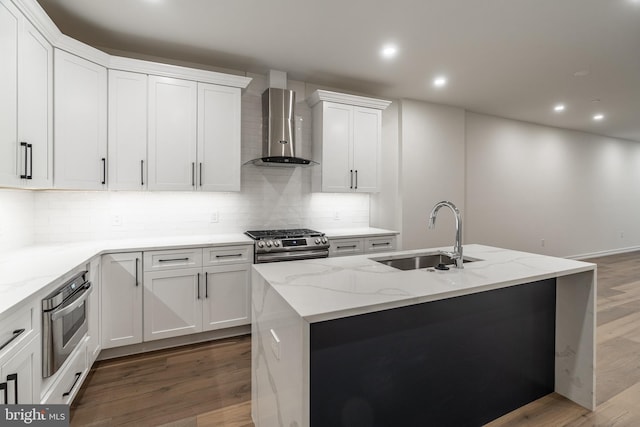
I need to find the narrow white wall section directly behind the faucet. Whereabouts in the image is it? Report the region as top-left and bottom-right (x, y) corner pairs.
(399, 100), (465, 249)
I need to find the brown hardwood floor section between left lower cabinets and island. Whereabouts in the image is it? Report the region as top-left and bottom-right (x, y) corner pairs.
(71, 336), (253, 427)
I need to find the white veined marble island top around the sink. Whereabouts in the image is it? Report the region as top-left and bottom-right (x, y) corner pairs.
(254, 244), (596, 322)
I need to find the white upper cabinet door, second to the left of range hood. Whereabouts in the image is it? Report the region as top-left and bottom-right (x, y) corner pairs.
(148, 76), (198, 190)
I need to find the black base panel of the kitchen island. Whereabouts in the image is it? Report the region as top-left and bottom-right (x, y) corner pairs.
(310, 279), (556, 427)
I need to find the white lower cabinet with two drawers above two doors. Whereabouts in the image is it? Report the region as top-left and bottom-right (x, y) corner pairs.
(144, 246), (252, 341)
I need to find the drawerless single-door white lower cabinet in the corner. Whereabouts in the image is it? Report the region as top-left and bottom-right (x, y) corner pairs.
(100, 252), (142, 349)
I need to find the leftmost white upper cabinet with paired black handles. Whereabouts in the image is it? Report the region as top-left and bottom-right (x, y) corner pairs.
(0, 2), (53, 188)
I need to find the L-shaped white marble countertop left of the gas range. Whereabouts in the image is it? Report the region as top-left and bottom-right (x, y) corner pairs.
(0, 233), (253, 318)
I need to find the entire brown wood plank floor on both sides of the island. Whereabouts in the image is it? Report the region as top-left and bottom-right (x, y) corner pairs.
(71, 252), (640, 427)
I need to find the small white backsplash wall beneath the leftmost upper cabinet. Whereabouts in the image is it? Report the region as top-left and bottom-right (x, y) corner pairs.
(0, 189), (34, 251)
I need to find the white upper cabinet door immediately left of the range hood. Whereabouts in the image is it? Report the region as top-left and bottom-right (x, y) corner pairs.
(197, 83), (241, 191)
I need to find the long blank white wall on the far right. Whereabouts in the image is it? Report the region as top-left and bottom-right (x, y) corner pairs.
(465, 113), (640, 256)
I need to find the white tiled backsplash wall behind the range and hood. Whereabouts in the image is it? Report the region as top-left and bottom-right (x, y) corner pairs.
(33, 75), (369, 243)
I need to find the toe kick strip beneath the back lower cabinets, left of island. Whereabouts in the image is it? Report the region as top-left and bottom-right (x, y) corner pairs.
(96, 325), (251, 360)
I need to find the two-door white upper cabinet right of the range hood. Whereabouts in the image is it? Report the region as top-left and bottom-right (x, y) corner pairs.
(308, 90), (390, 193)
